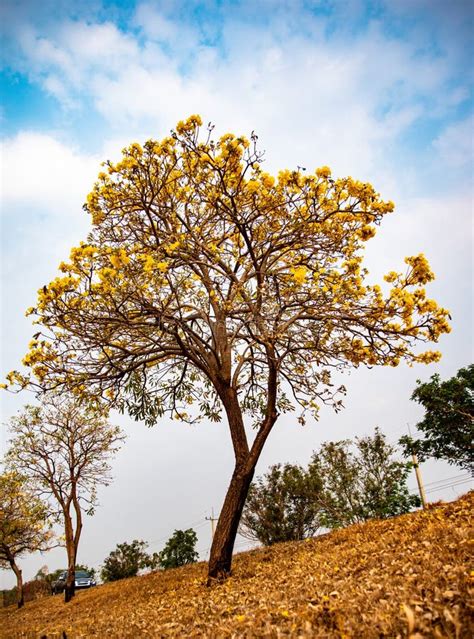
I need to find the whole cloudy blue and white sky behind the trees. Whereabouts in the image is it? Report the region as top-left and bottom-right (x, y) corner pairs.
(0, 0), (473, 587)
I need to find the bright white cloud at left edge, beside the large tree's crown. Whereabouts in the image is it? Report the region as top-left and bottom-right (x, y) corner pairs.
(0, 131), (99, 324)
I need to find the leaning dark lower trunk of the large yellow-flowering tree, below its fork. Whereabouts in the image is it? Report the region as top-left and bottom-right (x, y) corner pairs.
(208, 464), (255, 585)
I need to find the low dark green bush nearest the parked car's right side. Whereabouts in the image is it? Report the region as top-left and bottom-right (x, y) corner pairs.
(100, 539), (158, 581)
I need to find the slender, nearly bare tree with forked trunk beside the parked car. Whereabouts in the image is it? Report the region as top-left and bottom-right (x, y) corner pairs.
(6, 395), (124, 602)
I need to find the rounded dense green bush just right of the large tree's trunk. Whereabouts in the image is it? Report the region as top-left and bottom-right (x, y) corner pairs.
(240, 464), (322, 546)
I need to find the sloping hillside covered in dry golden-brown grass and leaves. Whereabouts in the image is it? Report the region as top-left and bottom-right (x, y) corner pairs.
(0, 492), (474, 639)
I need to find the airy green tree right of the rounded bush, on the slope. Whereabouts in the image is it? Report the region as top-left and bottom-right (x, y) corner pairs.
(308, 429), (420, 528)
